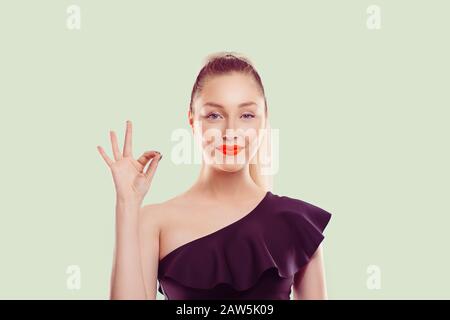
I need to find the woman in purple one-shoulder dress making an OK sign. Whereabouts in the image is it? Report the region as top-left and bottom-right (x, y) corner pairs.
(98, 53), (331, 299)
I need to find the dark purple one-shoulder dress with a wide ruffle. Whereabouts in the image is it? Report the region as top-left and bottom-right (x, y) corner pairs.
(158, 191), (331, 300)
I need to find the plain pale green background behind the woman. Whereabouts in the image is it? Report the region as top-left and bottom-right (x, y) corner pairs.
(0, 0), (450, 299)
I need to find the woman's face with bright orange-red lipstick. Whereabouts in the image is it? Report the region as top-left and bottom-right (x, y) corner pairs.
(189, 72), (266, 172)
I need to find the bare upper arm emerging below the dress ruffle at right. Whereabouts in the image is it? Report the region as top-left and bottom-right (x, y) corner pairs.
(293, 245), (328, 300)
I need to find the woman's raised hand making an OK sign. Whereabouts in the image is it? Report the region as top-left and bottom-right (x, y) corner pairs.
(97, 121), (162, 204)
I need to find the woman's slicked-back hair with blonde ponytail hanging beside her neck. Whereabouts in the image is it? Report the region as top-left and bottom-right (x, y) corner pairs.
(189, 52), (273, 191)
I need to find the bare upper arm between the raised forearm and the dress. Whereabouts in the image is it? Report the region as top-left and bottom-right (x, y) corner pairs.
(139, 204), (160, 300)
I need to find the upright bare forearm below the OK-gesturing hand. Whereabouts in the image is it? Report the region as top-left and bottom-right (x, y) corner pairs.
(110, 200), (146, 299)
